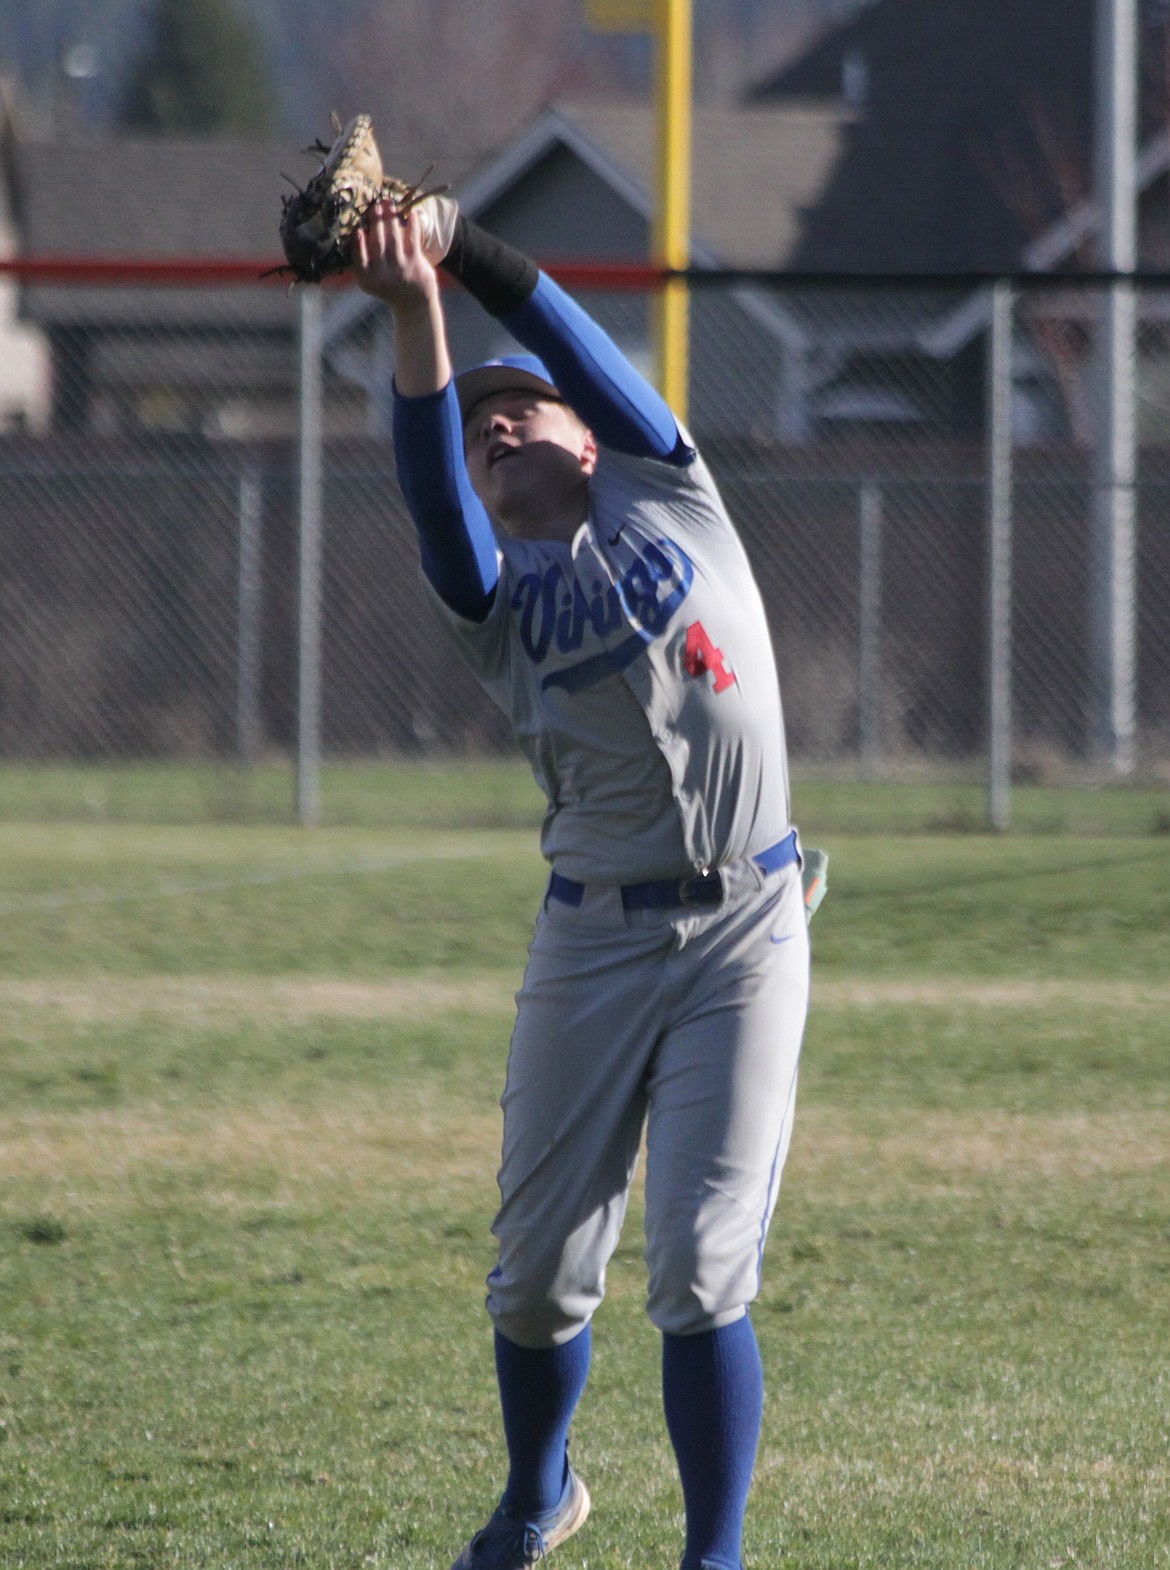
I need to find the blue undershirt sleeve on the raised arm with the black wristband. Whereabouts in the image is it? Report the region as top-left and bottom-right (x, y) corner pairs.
(503, 273), (694, 468)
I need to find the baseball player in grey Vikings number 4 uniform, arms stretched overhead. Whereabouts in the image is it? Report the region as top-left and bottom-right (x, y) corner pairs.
(353, 201), (809, 1570)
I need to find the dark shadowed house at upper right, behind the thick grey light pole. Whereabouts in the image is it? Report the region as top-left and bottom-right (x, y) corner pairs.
(748, 0), (1170, 444)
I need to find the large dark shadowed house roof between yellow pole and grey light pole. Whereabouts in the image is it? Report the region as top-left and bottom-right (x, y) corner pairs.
(749, 0), (1096, 272)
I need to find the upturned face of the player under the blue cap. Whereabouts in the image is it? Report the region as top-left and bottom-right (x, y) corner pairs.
(463, 391), (597, 540)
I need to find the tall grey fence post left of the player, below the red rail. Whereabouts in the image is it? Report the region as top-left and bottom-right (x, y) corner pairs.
(297, 289), (322, 824)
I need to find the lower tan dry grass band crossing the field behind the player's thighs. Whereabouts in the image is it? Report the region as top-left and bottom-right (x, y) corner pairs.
(0, 1085), (1170, 1203)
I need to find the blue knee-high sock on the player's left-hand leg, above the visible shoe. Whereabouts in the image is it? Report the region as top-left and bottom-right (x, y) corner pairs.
(496, 1325), (590, 1518)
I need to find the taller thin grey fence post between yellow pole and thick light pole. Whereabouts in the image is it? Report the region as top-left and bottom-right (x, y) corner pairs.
(986, 278), (1015, 829)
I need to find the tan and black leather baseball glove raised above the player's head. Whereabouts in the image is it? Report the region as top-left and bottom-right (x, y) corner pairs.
(272, 115), (459, 284)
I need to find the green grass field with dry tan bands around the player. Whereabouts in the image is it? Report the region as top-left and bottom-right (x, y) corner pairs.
(0, 765), (1170, 1570)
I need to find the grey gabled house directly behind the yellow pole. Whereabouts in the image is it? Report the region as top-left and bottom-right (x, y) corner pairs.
(327, 102), (848, 441)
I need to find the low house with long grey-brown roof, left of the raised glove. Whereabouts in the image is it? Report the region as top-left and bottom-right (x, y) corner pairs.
(13, 124), (298, 436)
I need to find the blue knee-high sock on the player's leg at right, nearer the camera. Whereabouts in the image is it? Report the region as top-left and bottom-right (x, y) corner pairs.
(663, 1314), (763, 1570)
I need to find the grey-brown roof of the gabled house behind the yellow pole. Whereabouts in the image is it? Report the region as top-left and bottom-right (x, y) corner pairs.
(459, 102), (853, 267)
